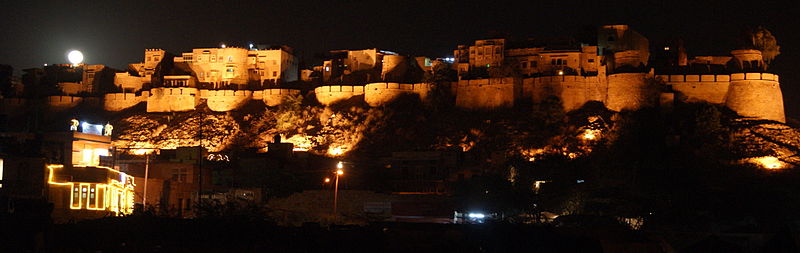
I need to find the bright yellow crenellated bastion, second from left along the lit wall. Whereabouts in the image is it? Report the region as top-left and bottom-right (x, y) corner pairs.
(147, 87), (200, 112)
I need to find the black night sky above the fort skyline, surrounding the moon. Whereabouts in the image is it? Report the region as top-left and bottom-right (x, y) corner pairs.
(0, 0), (800, 118)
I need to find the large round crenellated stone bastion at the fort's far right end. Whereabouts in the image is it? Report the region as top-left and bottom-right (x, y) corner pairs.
(725, 73), (786, 122)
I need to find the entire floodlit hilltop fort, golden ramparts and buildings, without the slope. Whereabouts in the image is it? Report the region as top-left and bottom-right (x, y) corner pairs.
(3, 25), (785, 122)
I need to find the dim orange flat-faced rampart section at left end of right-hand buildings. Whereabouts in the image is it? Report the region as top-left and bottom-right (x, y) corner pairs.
(456, 78), (514, 109)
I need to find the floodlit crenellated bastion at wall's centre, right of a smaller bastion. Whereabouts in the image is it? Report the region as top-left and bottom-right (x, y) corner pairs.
(364, 83), (431, 107)
